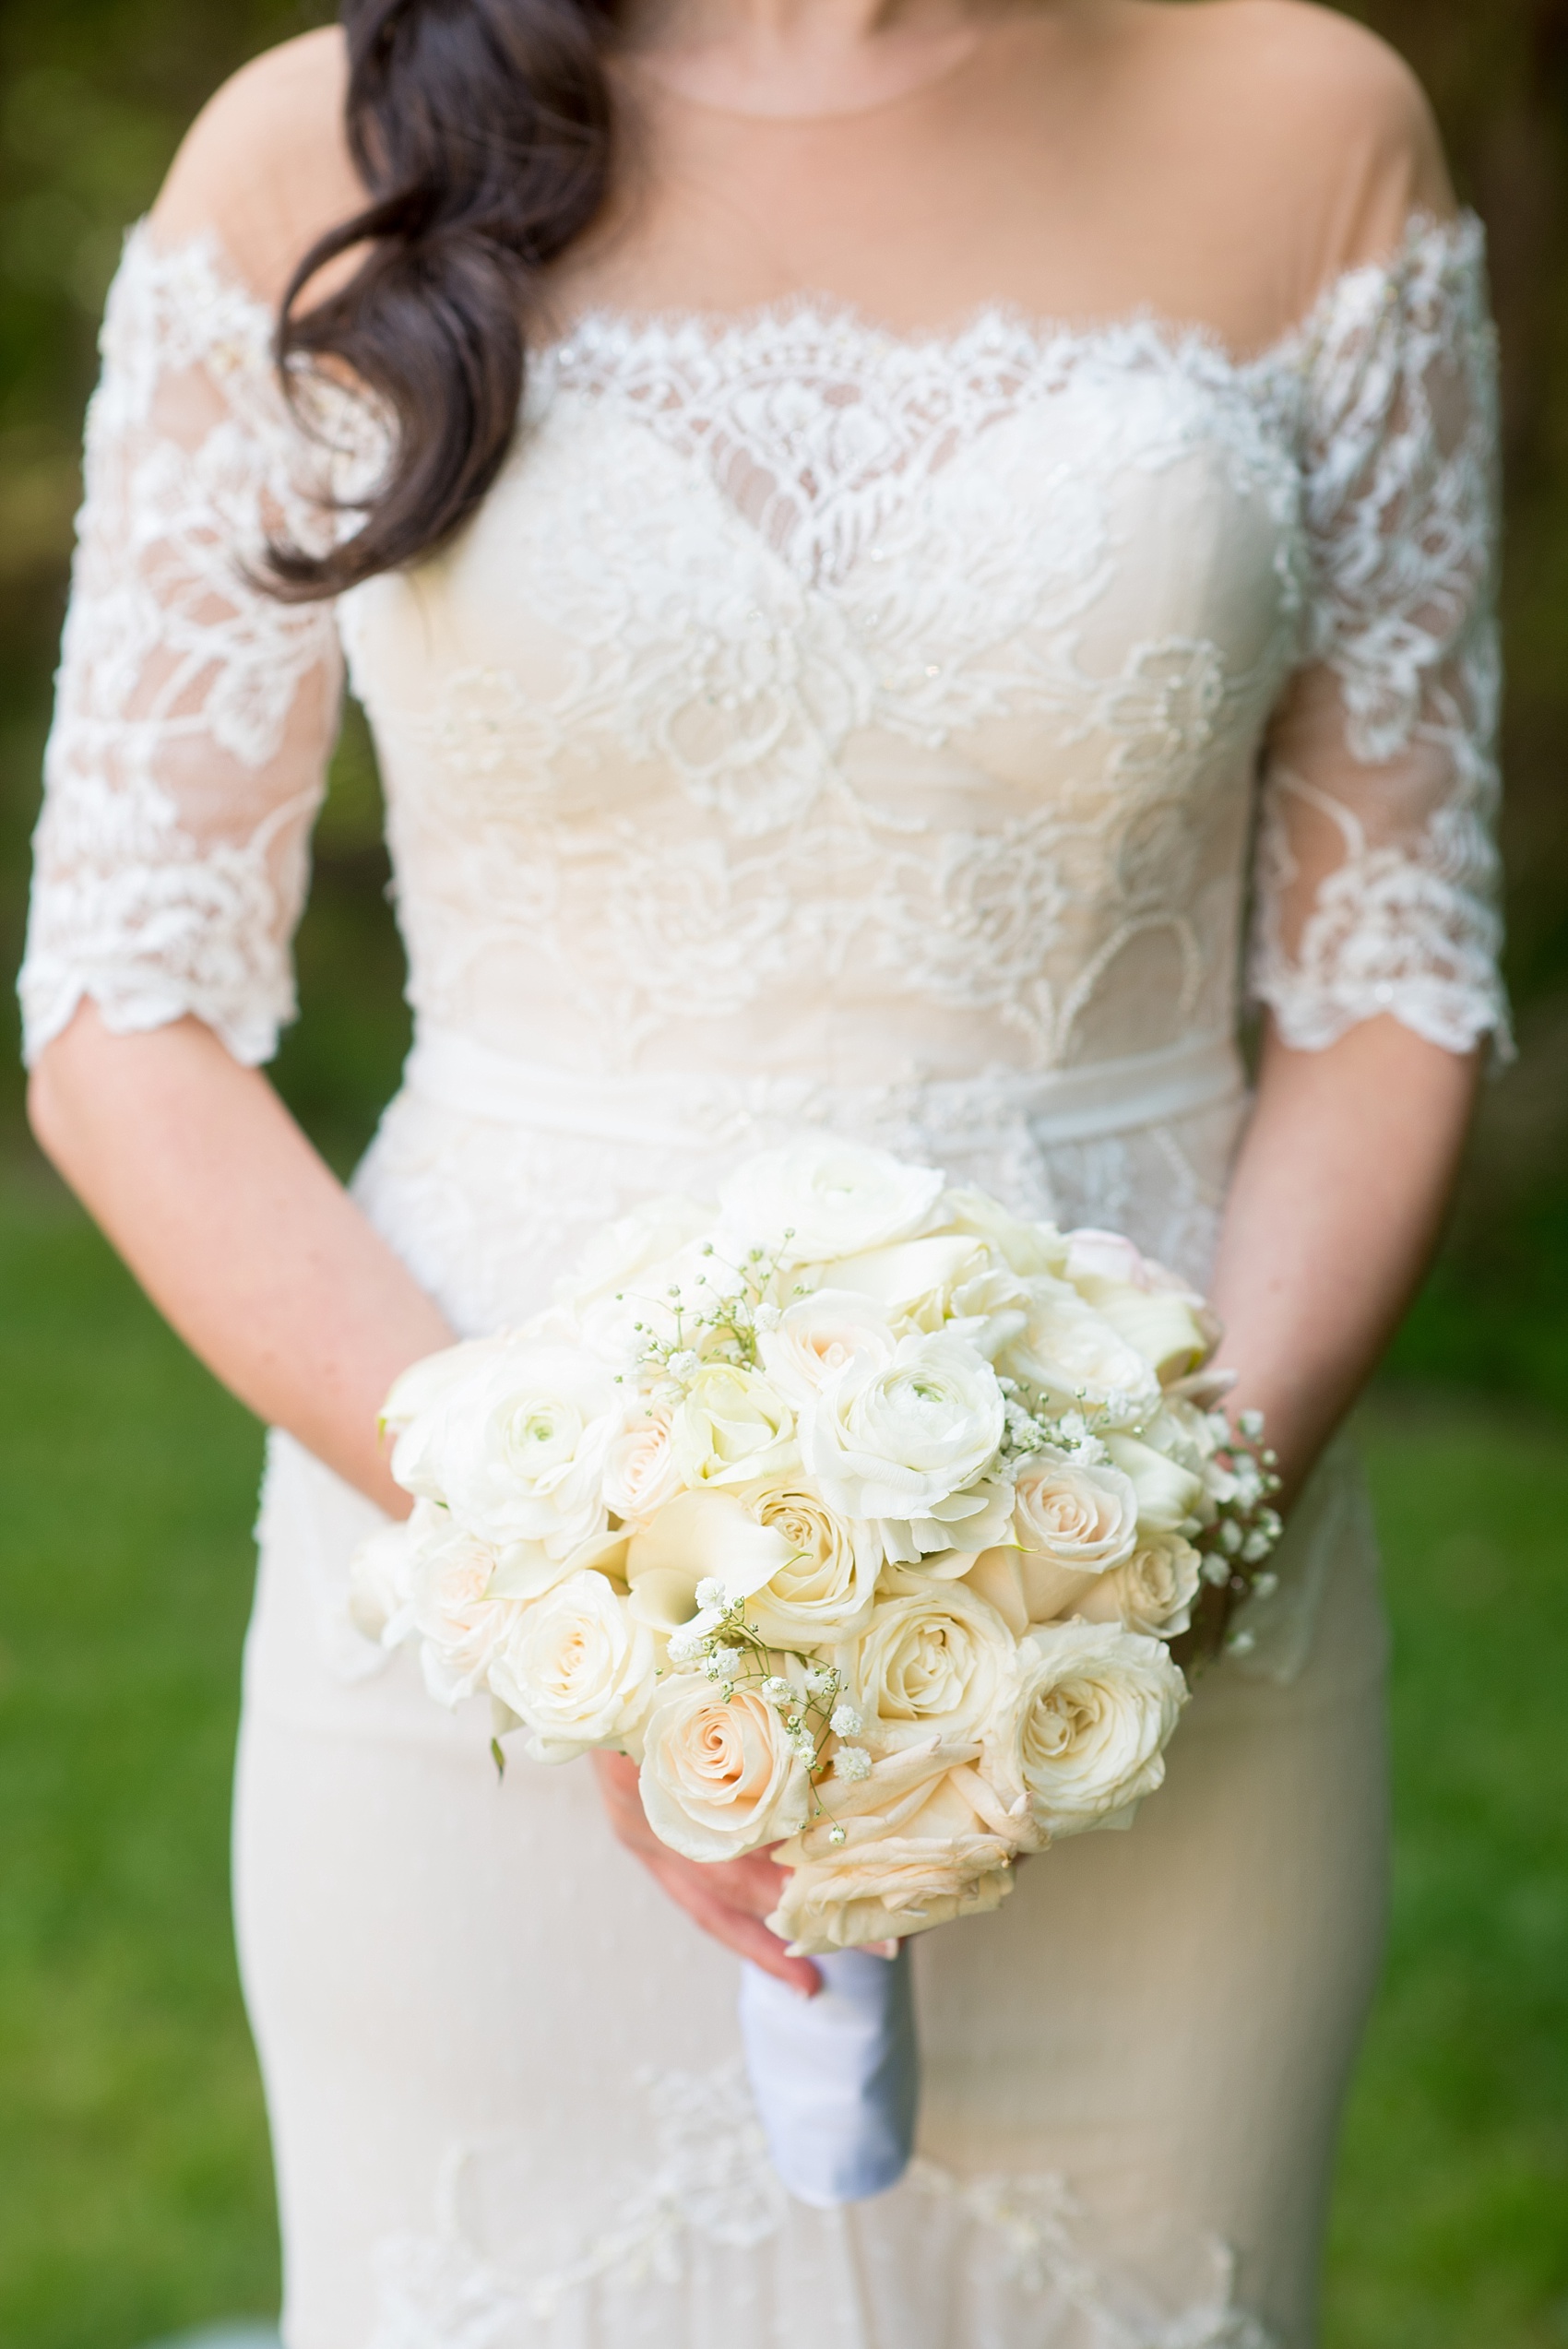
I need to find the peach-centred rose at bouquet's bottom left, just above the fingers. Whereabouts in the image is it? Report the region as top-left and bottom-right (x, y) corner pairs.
(639, 1675), (811, 1860)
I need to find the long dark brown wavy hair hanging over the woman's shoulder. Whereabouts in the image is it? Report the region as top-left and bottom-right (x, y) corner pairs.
(273, 0), (613, 601)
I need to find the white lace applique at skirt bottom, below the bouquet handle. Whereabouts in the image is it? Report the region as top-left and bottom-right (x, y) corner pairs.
(372, 2062), (1277, 2349)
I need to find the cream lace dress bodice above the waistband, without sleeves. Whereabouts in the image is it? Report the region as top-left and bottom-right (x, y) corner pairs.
(343, 308), (1307, 1083)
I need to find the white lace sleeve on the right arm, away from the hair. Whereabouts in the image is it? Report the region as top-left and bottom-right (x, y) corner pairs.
(1251, 219), (1507, 1052)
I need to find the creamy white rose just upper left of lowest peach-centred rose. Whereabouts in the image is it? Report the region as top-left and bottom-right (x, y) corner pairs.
(489, 1572), (659, 1762)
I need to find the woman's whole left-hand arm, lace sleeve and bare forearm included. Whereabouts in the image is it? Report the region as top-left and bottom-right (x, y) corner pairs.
(21, 35), (449, 1508)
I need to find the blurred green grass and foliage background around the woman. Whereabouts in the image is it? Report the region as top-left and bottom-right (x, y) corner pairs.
(0, 0), (1568, 2349)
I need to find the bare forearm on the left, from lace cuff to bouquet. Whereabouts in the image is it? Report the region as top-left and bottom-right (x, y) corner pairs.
(29, 1003), (451, 1515)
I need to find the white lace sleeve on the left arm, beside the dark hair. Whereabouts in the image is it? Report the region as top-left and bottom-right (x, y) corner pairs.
(21, 228), (341, 1062)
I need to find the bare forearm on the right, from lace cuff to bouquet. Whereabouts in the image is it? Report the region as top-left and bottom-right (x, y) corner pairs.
(1213, 1017), (1477, 1508)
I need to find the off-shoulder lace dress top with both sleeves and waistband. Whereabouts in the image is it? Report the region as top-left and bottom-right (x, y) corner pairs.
(21, 216), (1503, 1325)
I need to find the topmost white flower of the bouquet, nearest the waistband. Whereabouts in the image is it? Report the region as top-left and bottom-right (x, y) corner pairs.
(719, 1134), (943, 1263)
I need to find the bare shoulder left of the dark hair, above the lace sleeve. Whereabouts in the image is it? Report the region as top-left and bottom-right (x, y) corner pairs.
(153, 26), (364, 303)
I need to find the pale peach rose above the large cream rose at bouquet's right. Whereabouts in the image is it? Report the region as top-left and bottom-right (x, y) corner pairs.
(968, 1452), (1138, 1637)
